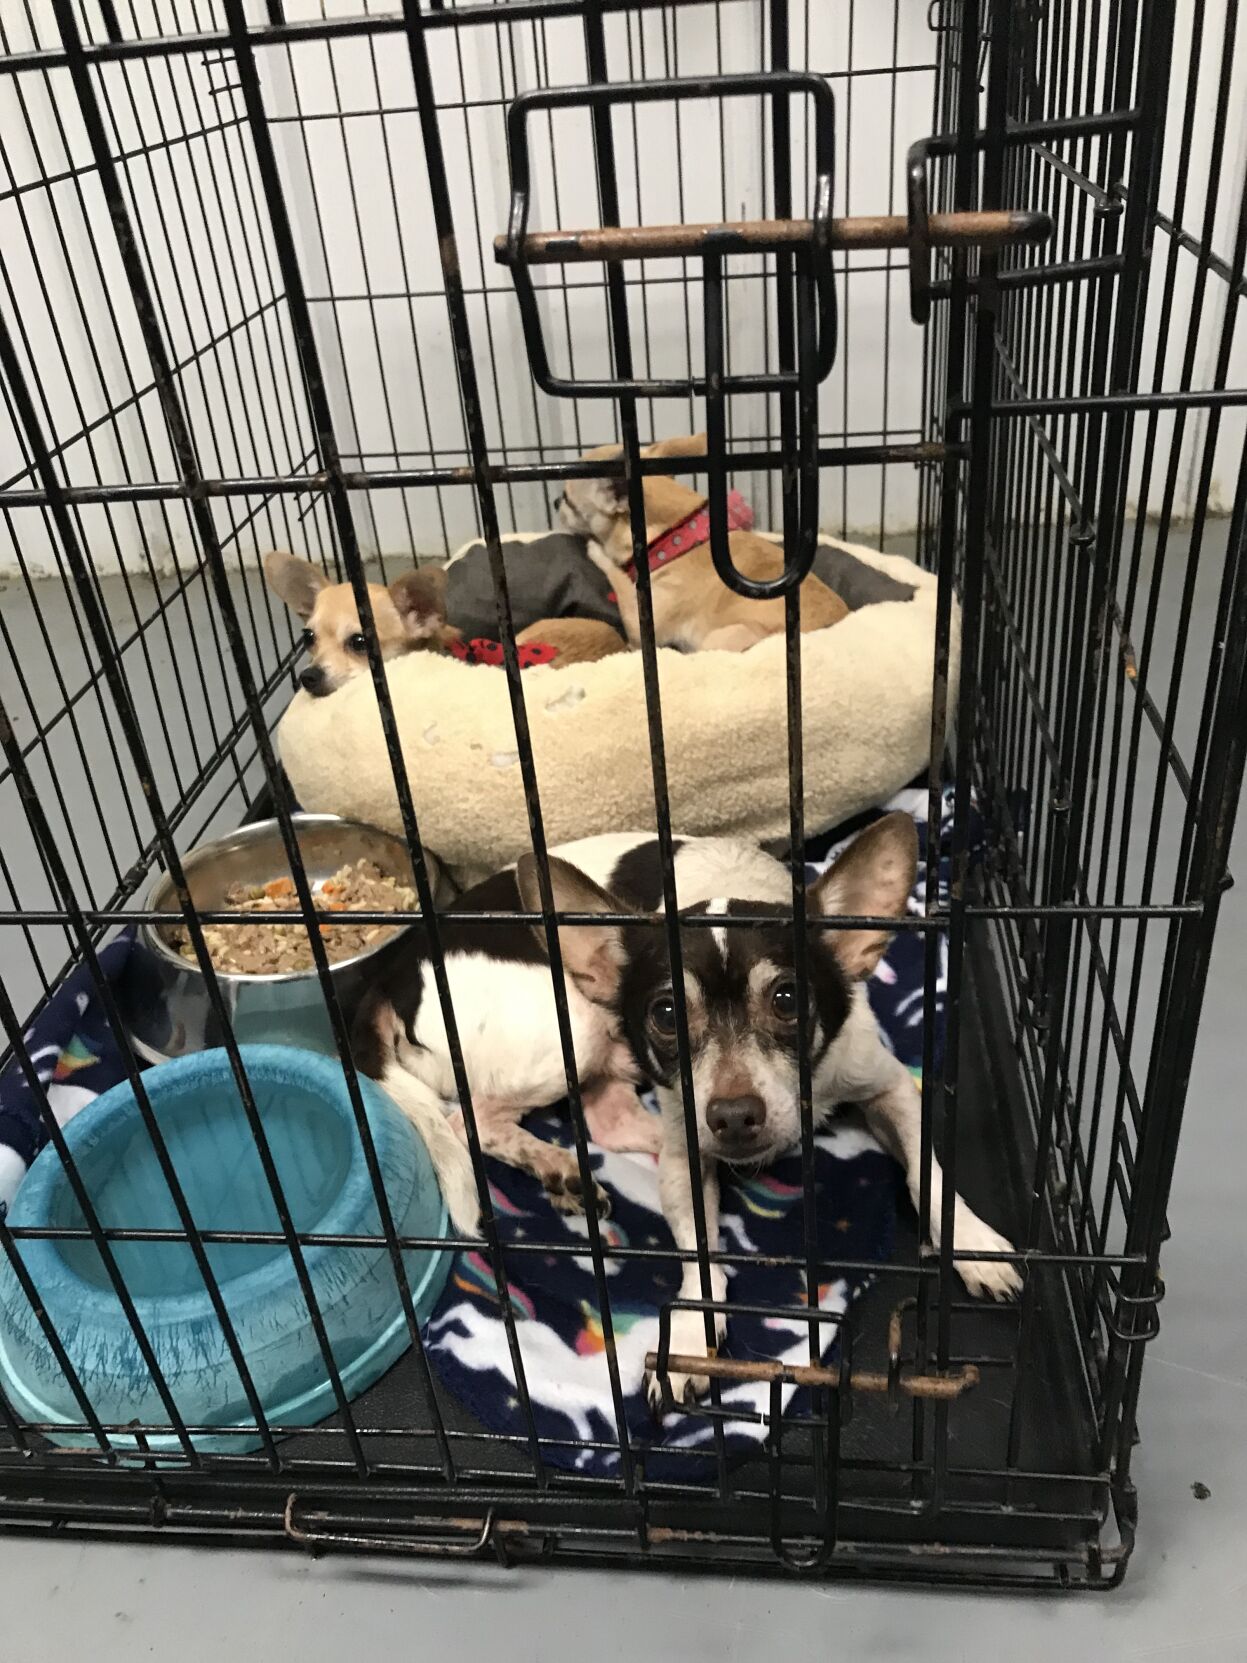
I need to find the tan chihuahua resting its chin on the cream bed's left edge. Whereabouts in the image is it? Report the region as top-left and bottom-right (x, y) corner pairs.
(264, 549), (627, 698)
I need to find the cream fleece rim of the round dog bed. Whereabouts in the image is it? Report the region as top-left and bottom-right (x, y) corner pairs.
(278, 537), (961, 881)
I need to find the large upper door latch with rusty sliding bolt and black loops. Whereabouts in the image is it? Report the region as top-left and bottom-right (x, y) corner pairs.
(494, 70), (1052, 600)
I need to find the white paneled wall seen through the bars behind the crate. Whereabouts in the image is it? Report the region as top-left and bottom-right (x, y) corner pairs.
(0, 0), (1247, 570)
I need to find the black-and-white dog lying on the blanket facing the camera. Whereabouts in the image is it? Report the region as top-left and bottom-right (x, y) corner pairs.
(352, 813), (1021, 1402)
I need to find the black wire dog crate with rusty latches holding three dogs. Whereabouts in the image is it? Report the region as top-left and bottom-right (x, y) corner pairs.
(0, 0), (1247, 1587)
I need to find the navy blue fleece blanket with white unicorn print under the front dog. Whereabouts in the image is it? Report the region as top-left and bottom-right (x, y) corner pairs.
(0, 788), (953, 1478)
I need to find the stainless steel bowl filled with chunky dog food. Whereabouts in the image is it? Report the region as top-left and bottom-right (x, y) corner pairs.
(120, 815), (439, 1063)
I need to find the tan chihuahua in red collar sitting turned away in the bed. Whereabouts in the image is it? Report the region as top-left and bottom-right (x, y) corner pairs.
(559, 432), (848, 652)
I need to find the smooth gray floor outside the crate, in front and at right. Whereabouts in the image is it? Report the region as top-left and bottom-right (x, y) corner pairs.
(0, 542), (1247, 1663)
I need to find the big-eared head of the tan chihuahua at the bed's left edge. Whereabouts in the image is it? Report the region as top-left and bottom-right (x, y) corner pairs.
(264, 549), (454, 698)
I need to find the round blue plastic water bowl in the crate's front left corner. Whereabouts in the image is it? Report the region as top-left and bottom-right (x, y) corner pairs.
(0, 1046), (454, 1453)
